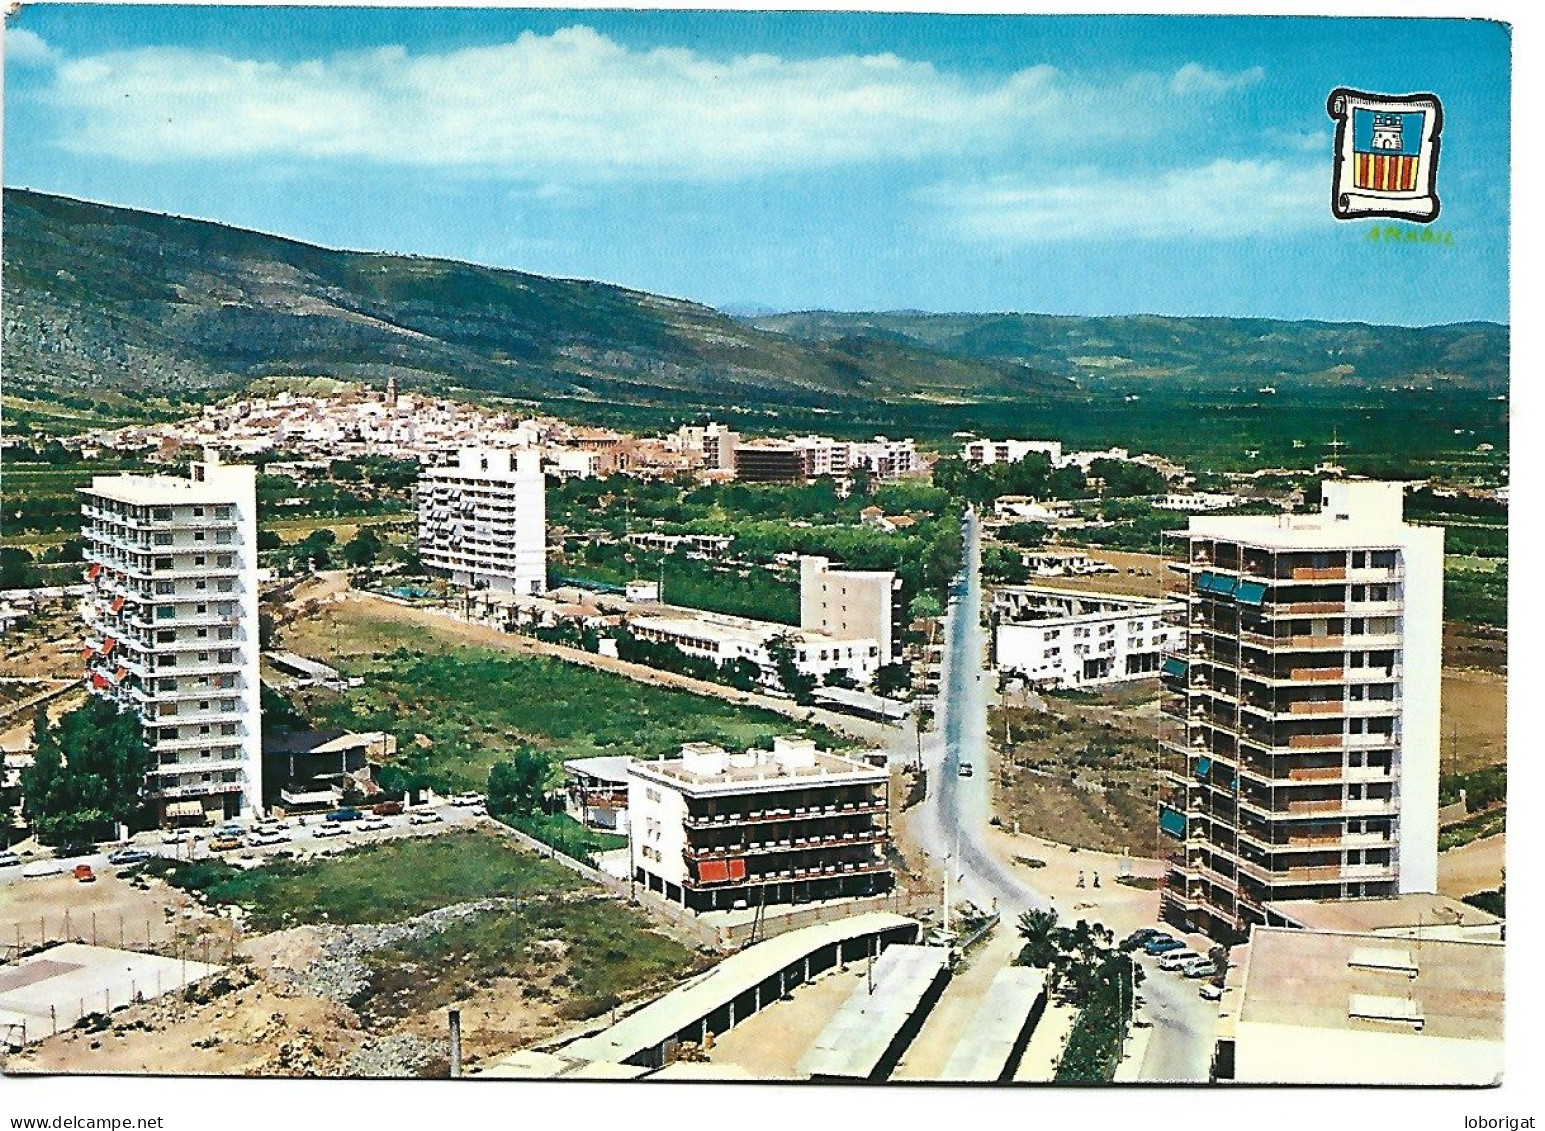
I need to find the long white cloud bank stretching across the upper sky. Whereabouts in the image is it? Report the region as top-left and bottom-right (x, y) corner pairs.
(39, 26), (1266, 182)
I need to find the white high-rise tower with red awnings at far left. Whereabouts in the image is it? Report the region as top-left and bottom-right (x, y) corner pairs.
(80, 453), (263, 824)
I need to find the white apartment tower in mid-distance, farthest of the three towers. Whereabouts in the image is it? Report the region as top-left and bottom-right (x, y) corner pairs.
(419, 448), (547, 596)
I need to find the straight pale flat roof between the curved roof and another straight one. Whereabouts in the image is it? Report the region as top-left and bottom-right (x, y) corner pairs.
(799, 944), (950, 1080)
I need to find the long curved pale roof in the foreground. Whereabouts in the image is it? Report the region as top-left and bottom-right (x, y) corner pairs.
(562, 912), (918, 1065)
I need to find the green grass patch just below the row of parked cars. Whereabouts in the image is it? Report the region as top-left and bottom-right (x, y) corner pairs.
(147, 831), (584, 932)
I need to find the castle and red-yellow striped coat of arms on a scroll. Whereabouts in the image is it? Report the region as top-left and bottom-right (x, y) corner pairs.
(1326, 87), (1443, 224)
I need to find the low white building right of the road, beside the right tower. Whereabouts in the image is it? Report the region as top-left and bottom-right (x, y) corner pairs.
(992, 586), (1180, 688)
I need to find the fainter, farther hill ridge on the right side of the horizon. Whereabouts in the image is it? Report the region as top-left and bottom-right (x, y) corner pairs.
(748, 311), (1508, 392)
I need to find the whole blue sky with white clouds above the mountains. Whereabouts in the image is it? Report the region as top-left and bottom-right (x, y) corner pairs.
(5, 5), (1508, 324)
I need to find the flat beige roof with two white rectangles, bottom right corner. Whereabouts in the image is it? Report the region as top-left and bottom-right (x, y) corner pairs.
(1239, 927), (1505, 1043)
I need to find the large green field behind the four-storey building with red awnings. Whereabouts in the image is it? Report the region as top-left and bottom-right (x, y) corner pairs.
(286, 606), (845, 790)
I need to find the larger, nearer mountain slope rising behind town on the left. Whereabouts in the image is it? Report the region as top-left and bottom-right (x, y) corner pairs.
(3, 189), (1066, 405)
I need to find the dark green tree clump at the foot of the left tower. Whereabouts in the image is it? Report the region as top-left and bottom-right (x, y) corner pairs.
(22, 695), (150, 845)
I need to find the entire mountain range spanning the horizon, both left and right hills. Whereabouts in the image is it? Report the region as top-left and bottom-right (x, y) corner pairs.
(3, 189), (1508, 423)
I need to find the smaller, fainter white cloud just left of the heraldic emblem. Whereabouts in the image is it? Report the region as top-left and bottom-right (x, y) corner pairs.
(925, 161), (1330, 244)
